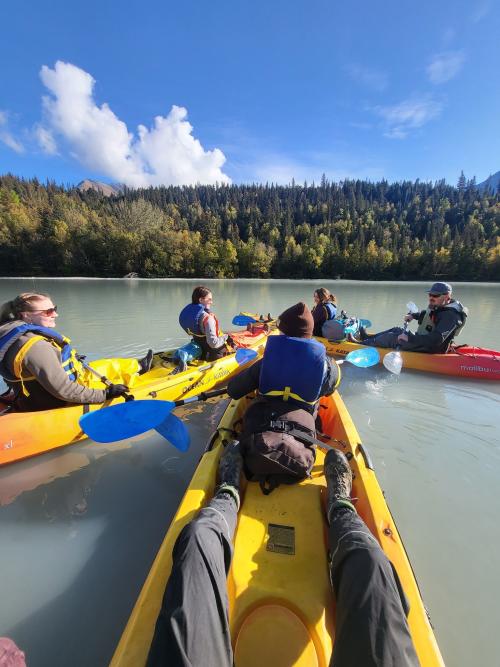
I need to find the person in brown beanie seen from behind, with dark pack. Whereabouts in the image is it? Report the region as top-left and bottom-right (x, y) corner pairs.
(227, 303), (340, 493)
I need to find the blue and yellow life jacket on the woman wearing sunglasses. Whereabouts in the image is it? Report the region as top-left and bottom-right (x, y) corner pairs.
(0, 324), (83, 396)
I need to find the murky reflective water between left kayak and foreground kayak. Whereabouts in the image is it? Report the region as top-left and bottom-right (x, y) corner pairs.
(0, 402), (224, 667)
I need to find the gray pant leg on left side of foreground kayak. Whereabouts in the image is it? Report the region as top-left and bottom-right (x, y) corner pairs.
(147, 493), (237, 667)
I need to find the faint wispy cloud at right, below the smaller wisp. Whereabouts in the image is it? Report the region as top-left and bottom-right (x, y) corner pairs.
(374, 97), (442, 139)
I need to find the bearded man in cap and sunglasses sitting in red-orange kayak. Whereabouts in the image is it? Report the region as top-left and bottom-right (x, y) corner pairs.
(348, 282), (468, 354)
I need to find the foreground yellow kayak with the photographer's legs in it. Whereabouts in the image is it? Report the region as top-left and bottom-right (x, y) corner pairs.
(111, 393), (444, 667)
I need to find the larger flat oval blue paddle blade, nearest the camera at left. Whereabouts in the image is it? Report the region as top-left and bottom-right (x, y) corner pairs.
(80, 401), (175, 442)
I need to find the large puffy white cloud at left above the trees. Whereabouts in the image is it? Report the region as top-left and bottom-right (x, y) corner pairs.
(37, 61), (230, 187)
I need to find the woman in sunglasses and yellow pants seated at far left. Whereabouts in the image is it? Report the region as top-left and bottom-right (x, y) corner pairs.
(0, 292), (153, 412)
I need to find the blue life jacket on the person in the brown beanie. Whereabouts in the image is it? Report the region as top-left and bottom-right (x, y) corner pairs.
(259, 336), (326, 405)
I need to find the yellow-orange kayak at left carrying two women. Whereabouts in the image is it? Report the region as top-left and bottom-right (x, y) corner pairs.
(0, 325), (273, 465)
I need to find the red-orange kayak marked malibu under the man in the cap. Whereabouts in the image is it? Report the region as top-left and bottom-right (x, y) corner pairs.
(317, 337), (500, 380)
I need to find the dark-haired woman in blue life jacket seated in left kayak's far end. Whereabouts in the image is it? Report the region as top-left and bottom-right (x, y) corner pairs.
(179, 285), (234, 361)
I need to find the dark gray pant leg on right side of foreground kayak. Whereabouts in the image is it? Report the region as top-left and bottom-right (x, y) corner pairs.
(329, 509), (419, 667)
